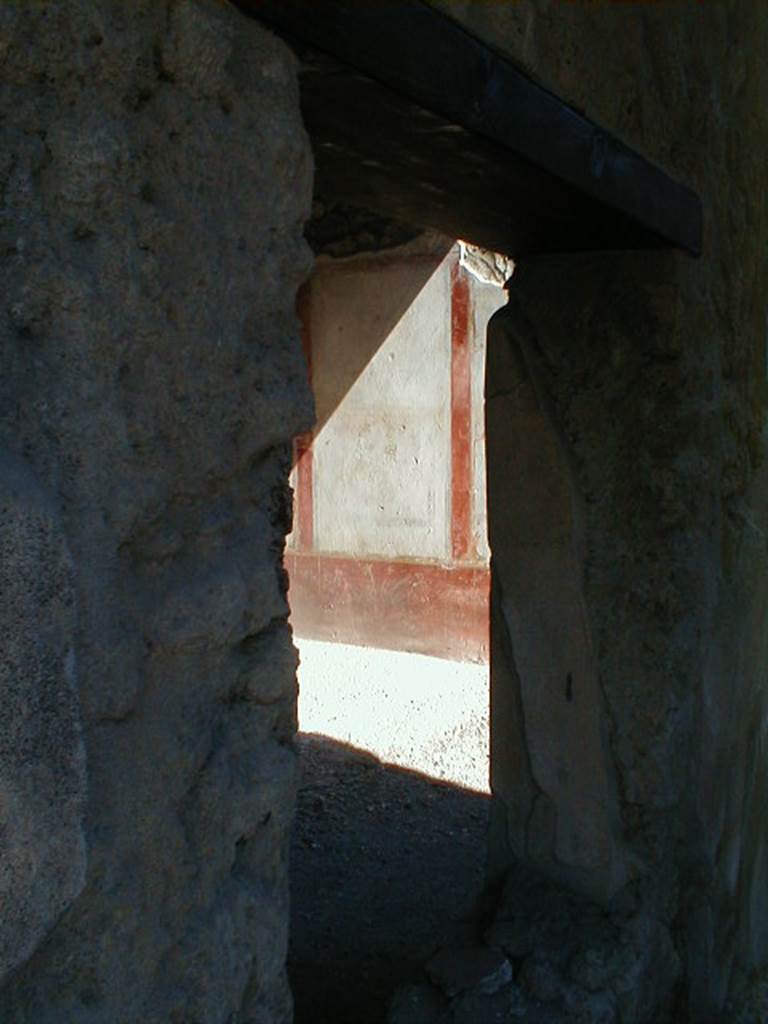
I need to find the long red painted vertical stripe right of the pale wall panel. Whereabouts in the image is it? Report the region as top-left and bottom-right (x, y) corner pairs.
(451, 261), (472, 561)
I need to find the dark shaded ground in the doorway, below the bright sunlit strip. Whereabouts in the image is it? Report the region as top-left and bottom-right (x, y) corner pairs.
(288, 735), (488, 1024)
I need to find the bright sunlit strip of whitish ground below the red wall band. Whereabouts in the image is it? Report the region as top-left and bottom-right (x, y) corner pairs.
(296, 638), (488, 793)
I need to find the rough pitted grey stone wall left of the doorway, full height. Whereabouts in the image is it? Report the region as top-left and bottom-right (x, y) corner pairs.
(0, 0), (312, 1024)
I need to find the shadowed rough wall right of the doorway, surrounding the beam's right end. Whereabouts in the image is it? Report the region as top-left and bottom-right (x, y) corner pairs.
(428, 0), (768, 1022)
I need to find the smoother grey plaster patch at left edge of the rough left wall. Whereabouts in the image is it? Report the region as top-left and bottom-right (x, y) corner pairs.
(0, 453), (85, 980)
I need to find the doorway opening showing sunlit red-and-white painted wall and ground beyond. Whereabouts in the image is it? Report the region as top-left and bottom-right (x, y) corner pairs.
(286, 201), (510, 1024)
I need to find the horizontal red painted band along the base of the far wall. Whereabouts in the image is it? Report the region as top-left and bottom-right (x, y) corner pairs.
(286, 551), (489, 663)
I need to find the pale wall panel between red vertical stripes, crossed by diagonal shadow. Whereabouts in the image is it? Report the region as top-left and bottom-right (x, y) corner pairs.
(311, 253), (451, 560)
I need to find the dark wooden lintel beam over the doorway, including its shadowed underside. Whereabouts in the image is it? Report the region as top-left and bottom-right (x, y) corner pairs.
(237, 0), (701, 256)
